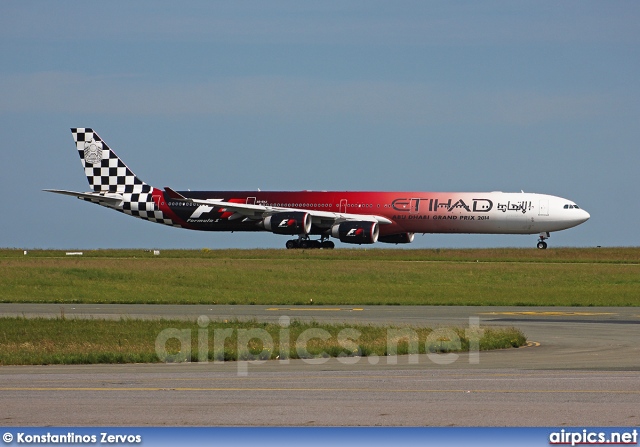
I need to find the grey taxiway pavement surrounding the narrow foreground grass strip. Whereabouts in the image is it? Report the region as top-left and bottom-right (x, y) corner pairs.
(0, 304), (640, 426)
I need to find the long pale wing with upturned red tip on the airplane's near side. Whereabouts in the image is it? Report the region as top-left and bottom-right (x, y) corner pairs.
(164, 187), (393, 226)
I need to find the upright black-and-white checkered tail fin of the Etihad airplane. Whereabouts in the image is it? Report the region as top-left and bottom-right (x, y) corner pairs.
(71, 127), (151, 193)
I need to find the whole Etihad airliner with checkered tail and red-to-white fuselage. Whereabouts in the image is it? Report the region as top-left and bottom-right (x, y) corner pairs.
(44, 127), (590, 249)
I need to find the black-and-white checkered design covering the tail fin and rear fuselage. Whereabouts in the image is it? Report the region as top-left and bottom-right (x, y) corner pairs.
(71, 127), (180, 227)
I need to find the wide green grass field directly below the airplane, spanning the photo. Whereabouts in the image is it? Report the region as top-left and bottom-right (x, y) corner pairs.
(0, 248), (640, 306)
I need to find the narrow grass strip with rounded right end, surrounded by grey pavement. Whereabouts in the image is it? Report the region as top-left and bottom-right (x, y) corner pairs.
(0, 318), (526, 365)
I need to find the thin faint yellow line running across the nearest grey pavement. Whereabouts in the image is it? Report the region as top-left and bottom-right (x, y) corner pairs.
(0, 387), (640, 394)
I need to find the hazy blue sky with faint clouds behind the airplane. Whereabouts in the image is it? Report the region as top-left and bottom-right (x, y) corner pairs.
(0, 1), (640, 249)
